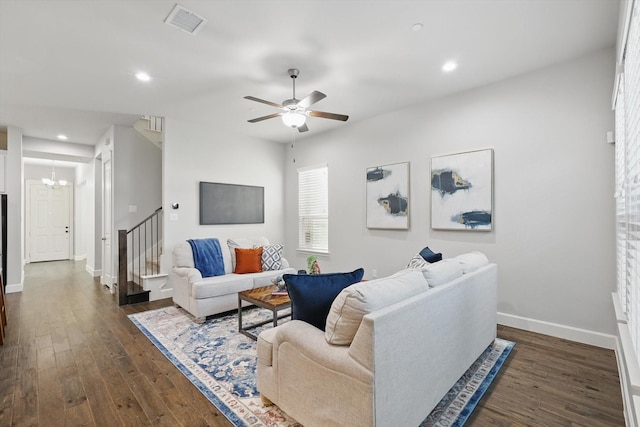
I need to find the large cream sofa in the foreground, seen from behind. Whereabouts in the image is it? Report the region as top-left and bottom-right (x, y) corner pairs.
(257, 253), (497, 427)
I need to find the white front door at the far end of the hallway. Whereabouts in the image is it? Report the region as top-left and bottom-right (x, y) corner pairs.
(29, 184), (71, 262)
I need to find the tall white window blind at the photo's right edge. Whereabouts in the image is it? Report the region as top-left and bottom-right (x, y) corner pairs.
(615, 1), (640, 359)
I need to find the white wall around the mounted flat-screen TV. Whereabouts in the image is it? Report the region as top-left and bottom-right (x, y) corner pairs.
(163, 117), (292, 271)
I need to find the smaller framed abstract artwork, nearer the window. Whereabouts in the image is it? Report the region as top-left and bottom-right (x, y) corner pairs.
(366, 162), (409, 230)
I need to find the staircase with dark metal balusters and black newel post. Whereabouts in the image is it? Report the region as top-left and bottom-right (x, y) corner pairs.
(118, 207), (166, 305)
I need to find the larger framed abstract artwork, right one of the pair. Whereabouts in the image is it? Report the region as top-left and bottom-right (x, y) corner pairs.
(431, 149), (493, 231)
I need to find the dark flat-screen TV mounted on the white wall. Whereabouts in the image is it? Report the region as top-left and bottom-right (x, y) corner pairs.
(200, 181), (264, 225)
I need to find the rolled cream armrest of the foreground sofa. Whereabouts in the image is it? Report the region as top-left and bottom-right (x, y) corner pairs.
(272, 320), (373, 382)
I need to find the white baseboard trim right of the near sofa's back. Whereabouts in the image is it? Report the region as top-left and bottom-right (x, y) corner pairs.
(498, 312), (616, 350)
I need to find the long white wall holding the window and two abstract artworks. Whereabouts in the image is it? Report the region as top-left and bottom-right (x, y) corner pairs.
(285, 48), (615, 346)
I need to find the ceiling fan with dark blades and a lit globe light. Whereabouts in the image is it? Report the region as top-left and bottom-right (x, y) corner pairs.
(244, 68), (349, 132)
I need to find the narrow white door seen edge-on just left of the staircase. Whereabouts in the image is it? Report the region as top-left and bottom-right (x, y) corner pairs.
(100, 150), (115, 293)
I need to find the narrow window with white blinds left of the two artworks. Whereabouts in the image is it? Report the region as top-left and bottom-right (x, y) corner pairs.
(298, 165), (329, 253)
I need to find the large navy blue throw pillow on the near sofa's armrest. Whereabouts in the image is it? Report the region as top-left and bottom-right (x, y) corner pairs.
(282, 268), (364, 331)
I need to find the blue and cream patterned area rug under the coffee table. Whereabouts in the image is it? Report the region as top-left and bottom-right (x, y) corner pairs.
(129, 307), (515, 427)
